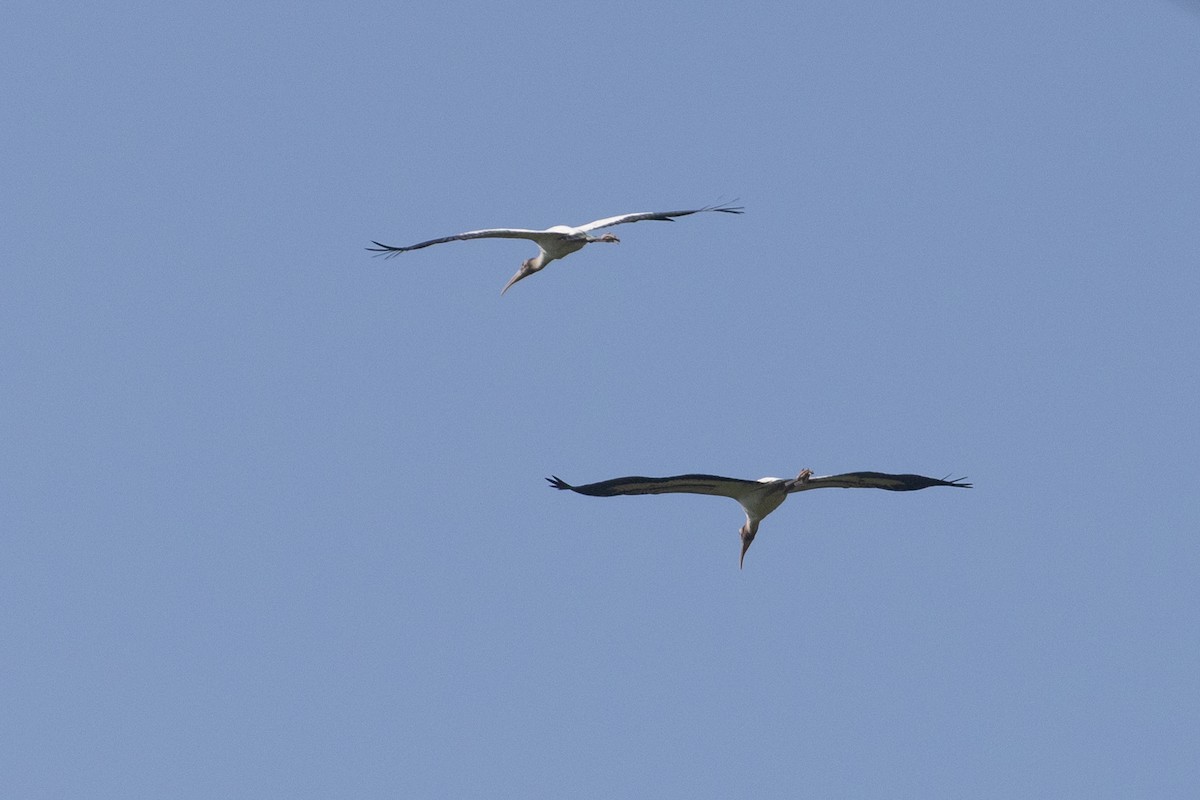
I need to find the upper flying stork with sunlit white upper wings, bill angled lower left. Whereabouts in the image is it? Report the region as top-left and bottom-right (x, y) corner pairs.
(367, 205), (743, 295)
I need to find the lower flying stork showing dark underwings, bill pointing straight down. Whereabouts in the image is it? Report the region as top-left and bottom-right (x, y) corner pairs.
(546, 469), (971, 569)
